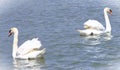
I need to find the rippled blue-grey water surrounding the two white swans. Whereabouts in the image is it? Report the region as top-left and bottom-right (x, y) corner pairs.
(0, 0), (120, 70)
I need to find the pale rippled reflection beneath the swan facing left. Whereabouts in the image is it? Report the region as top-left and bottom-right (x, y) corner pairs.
(13, 58), (45, 70)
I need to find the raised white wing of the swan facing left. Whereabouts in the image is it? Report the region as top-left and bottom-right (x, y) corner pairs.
(17, 38), (42, 55)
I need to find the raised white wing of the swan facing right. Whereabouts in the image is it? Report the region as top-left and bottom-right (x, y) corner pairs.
(84, 20), (105, 30)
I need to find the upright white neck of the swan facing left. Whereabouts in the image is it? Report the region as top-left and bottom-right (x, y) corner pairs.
(12, 31), (18, 58)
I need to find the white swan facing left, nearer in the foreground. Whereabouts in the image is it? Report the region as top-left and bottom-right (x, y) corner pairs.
(9, 27), (46, 59)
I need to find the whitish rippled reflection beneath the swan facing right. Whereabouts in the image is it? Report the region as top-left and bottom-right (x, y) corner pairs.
(82, 35), (112, 45)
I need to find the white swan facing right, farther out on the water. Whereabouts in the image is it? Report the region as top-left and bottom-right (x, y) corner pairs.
(77, 7), (112, 36)
